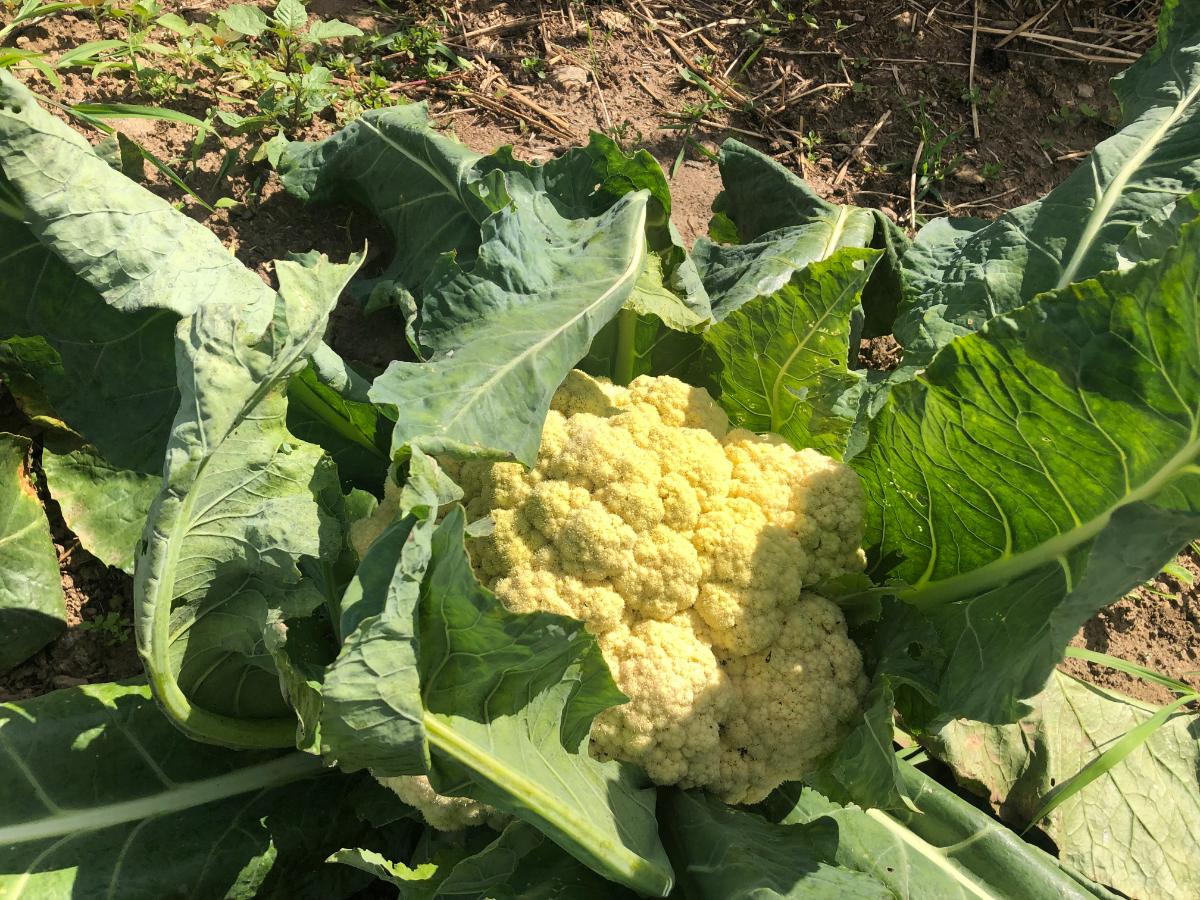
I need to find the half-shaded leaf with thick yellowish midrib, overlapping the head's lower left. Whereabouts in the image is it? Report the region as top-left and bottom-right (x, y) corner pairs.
(419, 506), (672, 896)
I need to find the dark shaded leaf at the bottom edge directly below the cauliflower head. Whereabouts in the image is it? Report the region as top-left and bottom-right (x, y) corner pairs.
(662, 788), (896, 900)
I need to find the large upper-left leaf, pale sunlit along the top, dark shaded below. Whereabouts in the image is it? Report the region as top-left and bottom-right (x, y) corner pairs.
(0, 71), (369, 480)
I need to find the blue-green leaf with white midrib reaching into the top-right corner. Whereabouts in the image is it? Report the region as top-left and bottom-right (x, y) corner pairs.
(895, 0), (1200, 365)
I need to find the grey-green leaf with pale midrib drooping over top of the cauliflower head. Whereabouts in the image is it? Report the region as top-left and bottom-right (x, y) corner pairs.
(370, 194), (646, 463)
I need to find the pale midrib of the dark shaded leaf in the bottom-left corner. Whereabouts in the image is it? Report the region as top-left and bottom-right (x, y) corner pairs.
(0, 752), (324, 846)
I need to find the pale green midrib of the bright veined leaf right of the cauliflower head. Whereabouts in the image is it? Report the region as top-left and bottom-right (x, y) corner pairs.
(900, 432), (1200, 608)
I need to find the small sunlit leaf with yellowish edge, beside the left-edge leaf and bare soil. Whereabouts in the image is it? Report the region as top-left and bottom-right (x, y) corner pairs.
(42, 444), (162, 575)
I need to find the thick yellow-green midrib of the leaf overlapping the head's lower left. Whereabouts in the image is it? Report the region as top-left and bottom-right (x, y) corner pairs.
(424, 712), (671, 890)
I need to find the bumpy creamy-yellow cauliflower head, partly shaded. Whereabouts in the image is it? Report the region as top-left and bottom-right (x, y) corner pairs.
(455, 372), (866, 803)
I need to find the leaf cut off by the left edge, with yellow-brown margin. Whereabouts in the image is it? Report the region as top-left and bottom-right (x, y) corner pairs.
(0, 432), (66, 672)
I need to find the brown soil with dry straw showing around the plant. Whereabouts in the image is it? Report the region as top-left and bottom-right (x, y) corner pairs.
(0, 0), (1200, 702)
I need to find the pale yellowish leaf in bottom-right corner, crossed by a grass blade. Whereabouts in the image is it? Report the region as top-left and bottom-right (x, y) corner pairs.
(931, 672), (1200, 898)
